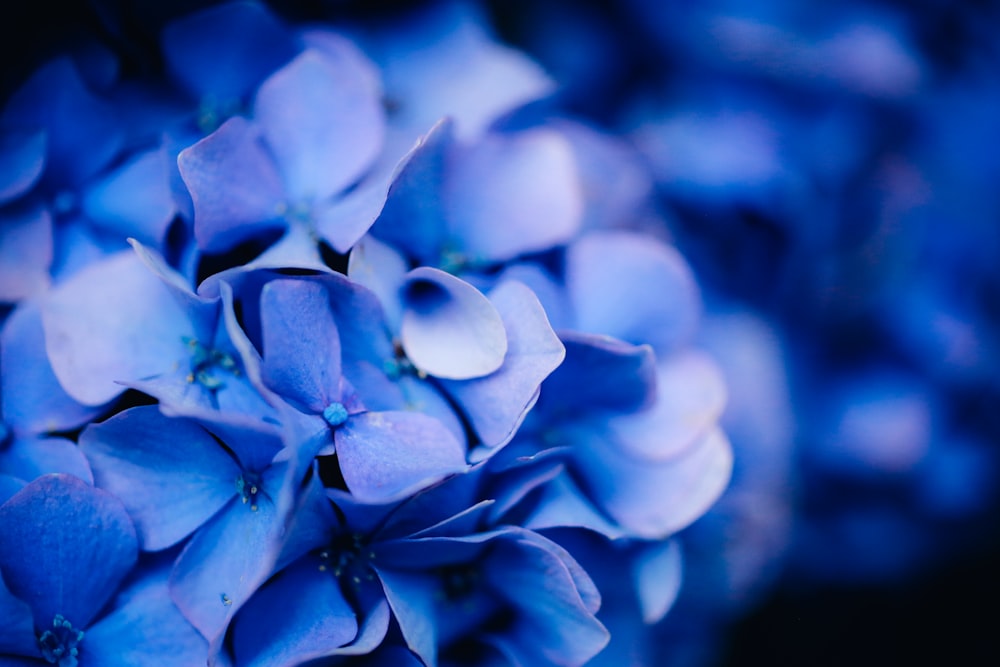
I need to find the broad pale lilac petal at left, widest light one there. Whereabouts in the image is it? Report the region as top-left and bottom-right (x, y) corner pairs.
(42, 251), (196, 405)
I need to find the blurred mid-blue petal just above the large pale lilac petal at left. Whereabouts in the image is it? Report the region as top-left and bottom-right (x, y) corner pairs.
(83, 149), (177, 248)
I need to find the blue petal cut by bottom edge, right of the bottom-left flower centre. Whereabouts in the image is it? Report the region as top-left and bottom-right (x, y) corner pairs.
(81, 567), (208, 667)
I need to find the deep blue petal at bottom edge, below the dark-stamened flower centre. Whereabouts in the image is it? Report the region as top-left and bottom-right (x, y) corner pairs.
(233, 558), (358, 667)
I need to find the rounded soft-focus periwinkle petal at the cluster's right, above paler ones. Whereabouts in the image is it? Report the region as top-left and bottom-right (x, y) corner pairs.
(566, 231), (700, 354)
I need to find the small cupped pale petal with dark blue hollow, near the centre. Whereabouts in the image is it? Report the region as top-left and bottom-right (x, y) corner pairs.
(401, 267), (507, 380)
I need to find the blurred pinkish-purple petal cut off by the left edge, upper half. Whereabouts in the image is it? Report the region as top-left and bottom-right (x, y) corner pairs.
(0, 206), (53, 303)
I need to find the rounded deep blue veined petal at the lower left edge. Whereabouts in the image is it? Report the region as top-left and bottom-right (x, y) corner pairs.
(0, 475), (138, 628)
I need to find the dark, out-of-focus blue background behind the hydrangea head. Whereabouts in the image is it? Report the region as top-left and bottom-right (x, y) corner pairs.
(0, 0), (1000, 666)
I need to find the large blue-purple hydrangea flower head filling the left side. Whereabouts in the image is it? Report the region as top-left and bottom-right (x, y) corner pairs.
(0, 2), (732, 667)
